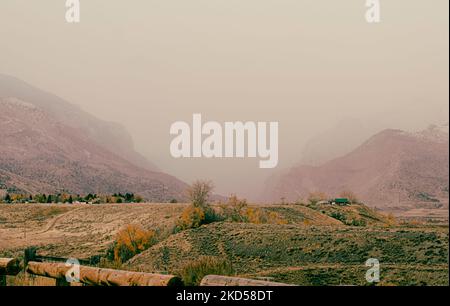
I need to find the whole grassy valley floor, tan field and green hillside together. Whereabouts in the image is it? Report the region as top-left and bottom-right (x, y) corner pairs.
(0, 204), (449, 285)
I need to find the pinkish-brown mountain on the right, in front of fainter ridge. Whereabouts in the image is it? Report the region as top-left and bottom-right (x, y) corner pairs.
(262, 125), (449, 208)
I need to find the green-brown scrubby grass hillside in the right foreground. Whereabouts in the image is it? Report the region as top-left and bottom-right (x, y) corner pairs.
(126, 222), (448, 285)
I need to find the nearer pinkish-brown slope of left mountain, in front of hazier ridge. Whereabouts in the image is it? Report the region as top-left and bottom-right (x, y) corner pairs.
(0, 99), (186, 201)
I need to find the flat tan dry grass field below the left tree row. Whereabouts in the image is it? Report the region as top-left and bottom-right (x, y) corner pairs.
(0, 204), (186, 258)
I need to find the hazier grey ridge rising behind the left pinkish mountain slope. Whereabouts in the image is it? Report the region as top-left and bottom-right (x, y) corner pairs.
(0, 74), (158, 170)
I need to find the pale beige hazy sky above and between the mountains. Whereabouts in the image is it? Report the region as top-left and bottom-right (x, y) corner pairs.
(0, 0), (449, 200)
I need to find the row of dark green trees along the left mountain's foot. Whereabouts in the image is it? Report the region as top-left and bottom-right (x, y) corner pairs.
(0, 193), (144, 204)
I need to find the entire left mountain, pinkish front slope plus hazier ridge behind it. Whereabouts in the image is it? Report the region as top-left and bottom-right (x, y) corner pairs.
(0, 75), (186, 201)
